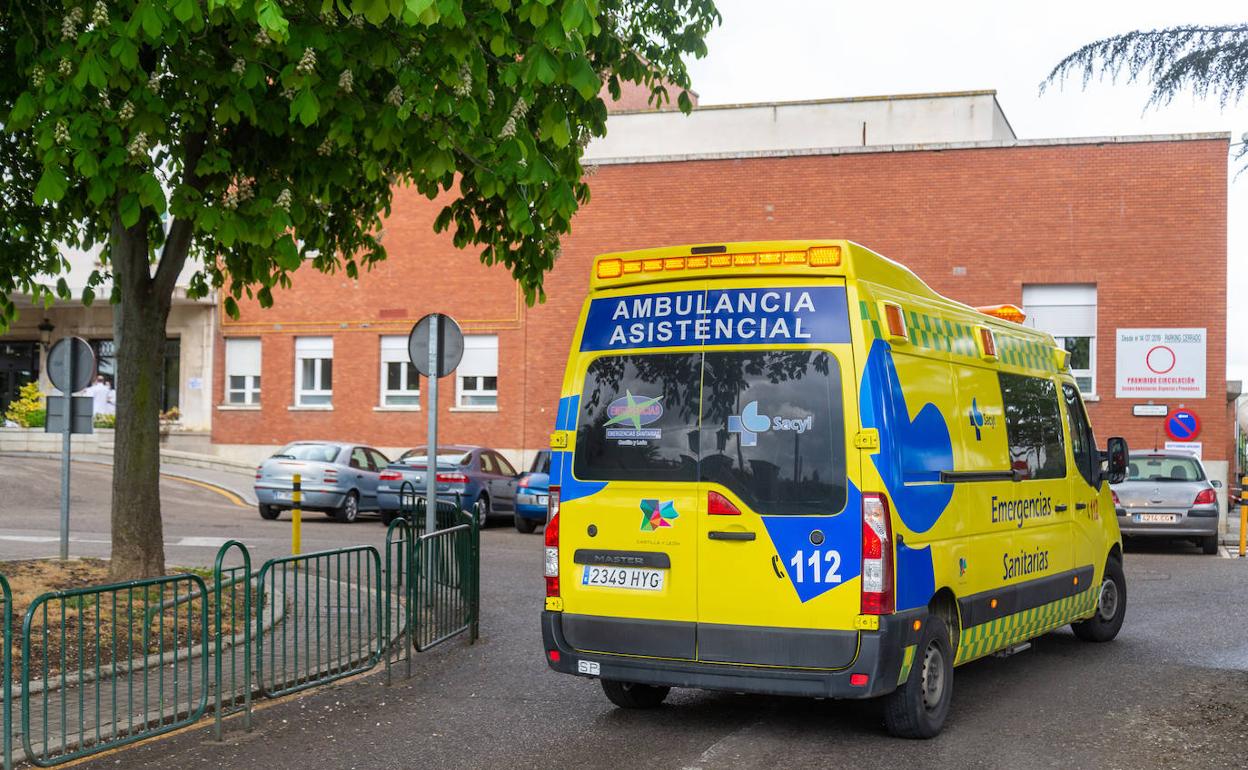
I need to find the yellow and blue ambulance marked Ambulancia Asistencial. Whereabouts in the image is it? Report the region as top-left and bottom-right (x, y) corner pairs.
(542, 241), (1127, 738)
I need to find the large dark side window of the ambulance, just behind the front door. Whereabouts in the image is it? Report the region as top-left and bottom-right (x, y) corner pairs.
(997, 372), (1066, 479)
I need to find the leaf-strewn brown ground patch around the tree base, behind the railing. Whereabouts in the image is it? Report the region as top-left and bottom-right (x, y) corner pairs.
(0, 559), (247, 681)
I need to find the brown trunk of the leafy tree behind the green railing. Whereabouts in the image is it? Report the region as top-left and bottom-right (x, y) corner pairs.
(110, 215), (172, 580)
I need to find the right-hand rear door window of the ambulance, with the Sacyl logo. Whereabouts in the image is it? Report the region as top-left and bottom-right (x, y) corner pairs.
(700, 351), (846, 515)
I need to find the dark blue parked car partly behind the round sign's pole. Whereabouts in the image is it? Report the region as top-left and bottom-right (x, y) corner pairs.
(377, 446), (519, 528)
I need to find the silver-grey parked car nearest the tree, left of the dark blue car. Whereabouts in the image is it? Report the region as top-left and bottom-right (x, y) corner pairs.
(256, 441), (389, 522)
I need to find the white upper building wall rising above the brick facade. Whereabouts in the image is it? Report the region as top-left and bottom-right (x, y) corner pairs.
(585, 91), (1015, 163)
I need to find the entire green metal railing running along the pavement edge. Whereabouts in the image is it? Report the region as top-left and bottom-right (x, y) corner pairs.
(0, 519), (480, 770)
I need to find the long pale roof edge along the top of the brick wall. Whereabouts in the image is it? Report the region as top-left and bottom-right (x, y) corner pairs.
(582, 131), (1231, 166)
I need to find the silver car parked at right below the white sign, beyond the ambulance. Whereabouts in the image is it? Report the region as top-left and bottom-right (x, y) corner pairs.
(1113, 452), (1222, 554)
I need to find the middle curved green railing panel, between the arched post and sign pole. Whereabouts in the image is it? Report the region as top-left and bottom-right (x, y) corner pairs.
(256, 545), (388, 698)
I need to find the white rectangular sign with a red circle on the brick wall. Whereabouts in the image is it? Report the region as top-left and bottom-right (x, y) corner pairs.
(1116, 328), (1206, 398)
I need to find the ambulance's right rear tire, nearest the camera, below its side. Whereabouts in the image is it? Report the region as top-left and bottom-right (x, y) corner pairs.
(884, 615), (953, 738)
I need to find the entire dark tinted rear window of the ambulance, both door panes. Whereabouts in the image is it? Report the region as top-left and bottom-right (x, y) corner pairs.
(573, 351), (846, 514)
